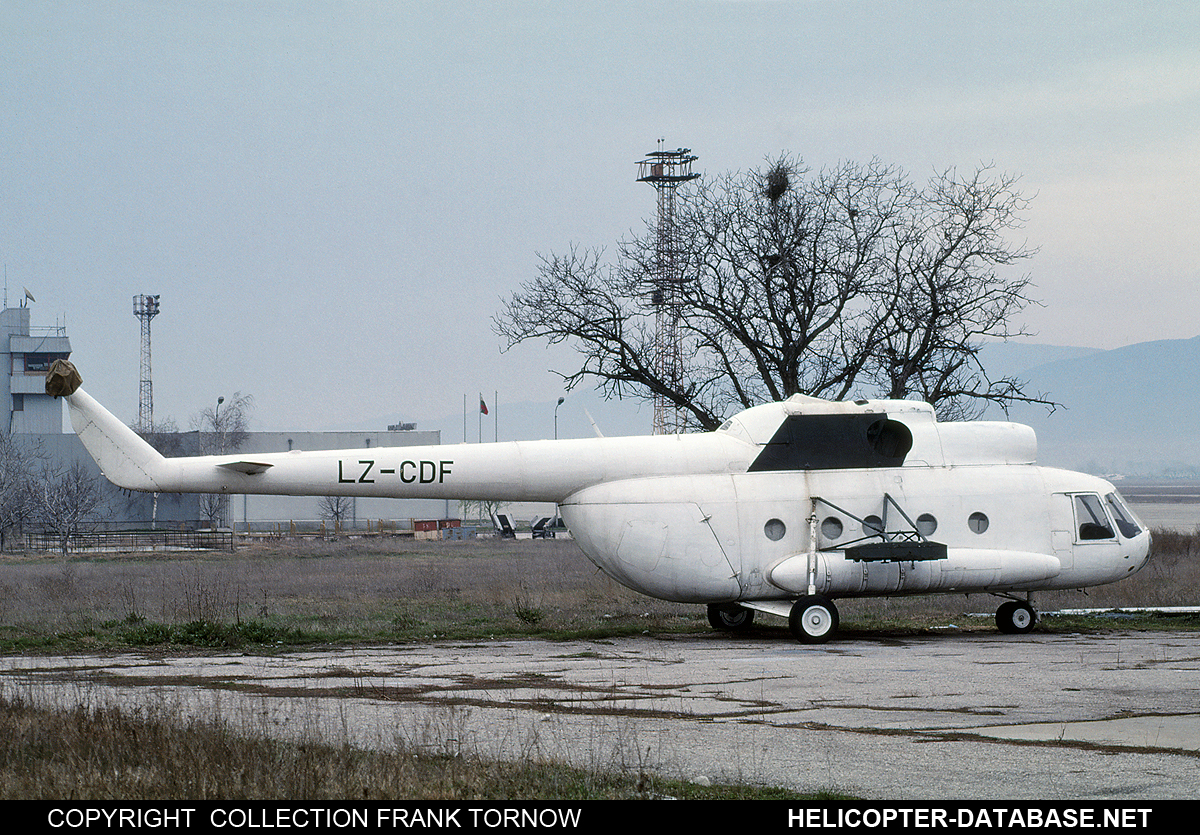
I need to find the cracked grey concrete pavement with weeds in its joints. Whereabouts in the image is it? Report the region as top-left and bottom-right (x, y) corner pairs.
(0, 632), (1200, 800)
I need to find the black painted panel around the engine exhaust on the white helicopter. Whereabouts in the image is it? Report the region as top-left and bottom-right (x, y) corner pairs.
(749, 414), (912, 473)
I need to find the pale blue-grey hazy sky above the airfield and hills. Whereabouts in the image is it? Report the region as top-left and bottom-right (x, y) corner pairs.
(0, 0), (1200, 440)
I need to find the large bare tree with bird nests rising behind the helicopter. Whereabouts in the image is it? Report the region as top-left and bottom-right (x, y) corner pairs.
(496, 157), (1046, 429)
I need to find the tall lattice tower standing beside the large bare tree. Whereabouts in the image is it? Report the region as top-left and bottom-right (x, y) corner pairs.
(637, 139), (700, 434)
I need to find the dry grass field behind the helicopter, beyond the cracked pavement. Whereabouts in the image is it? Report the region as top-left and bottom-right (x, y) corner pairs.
(0, 530), (1200, 651)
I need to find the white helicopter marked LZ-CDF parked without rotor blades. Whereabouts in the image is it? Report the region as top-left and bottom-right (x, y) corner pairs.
(47, 360), (1150, 643)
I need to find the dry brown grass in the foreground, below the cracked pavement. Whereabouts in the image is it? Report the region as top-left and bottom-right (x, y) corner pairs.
(0, 692), (809, 800)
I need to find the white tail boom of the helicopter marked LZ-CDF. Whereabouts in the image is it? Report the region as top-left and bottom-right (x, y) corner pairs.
(65, 389), (755, 503)
